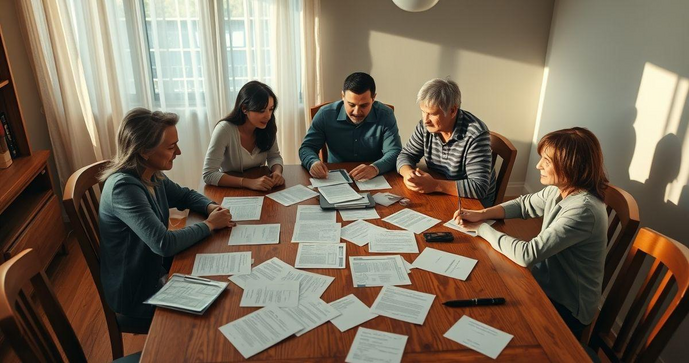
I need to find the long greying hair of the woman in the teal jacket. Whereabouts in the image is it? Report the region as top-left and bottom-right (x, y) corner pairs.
(99, 107), (179, 186)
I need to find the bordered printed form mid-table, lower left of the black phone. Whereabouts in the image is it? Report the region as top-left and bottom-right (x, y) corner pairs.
(349, 255), (411, 287)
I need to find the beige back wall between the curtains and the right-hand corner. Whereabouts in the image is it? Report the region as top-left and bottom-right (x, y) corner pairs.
(321, 0), (553, 194)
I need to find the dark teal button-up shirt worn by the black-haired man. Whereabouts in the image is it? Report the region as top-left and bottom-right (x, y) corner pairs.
(299, 101), (402, 174)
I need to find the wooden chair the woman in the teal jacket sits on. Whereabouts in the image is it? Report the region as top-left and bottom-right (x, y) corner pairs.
(62, 160), (148, 359)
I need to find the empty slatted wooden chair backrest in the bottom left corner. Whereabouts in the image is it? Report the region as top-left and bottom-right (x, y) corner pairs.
(0, 249), (86, 362)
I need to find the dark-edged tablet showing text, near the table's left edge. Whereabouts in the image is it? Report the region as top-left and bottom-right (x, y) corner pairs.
(144, 274), (228, 315)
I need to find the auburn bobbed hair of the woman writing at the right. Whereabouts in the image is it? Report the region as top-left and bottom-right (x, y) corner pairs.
(538, 127), (608, 200)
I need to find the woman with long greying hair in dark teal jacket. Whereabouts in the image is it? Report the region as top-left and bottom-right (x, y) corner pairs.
(98, 108), (235, 330)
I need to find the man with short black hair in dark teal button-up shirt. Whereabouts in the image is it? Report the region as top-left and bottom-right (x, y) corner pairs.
(299, 72), (402, 180)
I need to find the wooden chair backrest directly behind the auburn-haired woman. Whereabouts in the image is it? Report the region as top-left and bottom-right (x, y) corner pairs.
(603, 185), (639, 291)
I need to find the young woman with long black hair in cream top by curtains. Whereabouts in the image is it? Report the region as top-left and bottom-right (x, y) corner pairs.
(203, 81), (285, 191)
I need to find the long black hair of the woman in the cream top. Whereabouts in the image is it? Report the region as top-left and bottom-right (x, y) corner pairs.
(220, 81), (278, 151)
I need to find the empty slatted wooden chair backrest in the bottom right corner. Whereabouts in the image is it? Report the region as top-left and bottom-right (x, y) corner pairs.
(590, 228), (689, 362)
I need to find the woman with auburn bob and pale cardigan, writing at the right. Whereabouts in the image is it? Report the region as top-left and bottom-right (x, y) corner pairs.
(454, 127), (608, 338)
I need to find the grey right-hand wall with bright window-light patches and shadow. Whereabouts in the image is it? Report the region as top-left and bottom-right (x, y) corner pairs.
(527, 0), (689, 362)
